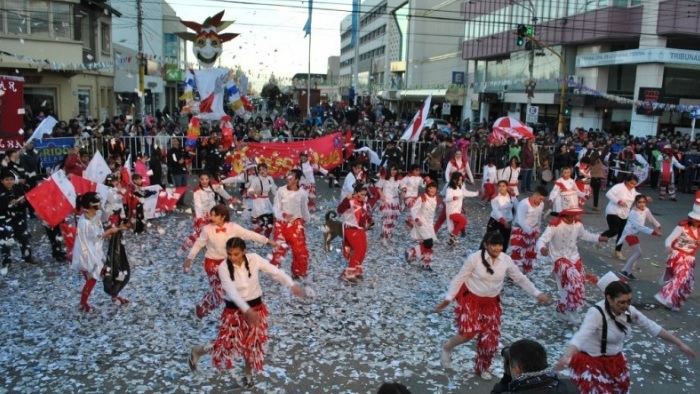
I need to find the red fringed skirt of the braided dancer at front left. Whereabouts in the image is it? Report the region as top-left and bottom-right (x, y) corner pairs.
(211, 304), (269, 371)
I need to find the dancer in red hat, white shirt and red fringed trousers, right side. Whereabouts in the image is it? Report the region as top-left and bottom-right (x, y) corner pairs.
(536, 208), (608, 324)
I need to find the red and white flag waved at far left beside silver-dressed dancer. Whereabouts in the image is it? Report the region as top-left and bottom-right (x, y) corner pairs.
(25, 170), (76, 227)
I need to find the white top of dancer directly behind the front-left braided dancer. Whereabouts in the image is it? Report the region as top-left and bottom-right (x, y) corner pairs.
(187, 222), (268, 260)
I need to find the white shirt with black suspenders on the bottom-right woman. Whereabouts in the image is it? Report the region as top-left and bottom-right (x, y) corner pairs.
(569, 301), (662, 357)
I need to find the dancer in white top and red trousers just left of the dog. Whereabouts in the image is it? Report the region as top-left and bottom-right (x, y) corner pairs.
(271, 170), (310, 279)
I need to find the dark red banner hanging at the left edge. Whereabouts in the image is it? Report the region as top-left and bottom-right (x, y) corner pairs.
(0, 75), (24, 151)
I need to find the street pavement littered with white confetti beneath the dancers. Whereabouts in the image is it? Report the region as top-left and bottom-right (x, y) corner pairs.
(0, 177), (700, 394)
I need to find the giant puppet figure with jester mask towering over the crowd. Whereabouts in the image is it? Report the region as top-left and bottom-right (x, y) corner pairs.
(177, 11), (249, 148)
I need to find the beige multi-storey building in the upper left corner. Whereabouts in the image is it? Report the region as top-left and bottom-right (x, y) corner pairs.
(0, 0), (121, 123)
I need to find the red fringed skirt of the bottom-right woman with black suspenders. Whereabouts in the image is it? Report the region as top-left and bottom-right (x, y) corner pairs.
(569, 352), (630, 394)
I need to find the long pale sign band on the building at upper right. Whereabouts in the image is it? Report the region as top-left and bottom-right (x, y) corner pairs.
(576, 48), (700, 67)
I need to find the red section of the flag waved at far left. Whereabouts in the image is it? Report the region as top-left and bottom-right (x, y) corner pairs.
(25, 178), (75, 227)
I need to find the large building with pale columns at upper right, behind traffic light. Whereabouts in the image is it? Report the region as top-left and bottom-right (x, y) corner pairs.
(462, 0), (700, 136)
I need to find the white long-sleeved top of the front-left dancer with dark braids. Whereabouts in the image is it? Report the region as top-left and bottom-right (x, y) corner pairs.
(217, 253), (294, 313)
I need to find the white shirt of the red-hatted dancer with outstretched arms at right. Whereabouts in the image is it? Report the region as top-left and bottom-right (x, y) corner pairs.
(535, 219), (600, 262)
